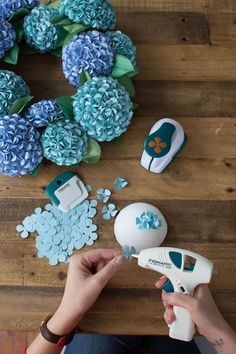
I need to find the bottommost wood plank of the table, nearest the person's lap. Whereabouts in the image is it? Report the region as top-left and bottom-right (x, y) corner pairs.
(0, 287), (236, 335)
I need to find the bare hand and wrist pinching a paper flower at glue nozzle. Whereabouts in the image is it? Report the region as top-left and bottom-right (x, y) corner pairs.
(48, 249), (125, 335)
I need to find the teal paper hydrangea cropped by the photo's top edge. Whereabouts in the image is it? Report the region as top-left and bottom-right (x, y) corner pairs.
(59, 0), (116, 30)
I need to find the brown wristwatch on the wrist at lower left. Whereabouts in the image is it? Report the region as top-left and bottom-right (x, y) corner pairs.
(40, 314), (75, 347)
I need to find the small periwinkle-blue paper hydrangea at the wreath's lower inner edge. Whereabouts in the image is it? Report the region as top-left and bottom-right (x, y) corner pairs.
(25, 100), (64, 128)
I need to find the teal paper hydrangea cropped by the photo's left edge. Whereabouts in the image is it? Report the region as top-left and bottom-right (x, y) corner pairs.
(0, 70), (30, 116)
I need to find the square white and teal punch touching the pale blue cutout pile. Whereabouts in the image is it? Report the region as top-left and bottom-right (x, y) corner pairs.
(45, 172), (88, 213)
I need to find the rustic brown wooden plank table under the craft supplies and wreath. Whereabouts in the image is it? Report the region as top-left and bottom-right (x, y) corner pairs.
(0, 0), (236, 334)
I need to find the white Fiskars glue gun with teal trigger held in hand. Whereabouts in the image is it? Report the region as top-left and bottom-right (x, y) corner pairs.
(132, 247), (213, 342)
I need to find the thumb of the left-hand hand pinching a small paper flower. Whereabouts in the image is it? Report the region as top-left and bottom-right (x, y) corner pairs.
(94, 254), (126, 287)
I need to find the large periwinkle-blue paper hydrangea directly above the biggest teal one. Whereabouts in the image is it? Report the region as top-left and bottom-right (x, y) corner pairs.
(62, 31), (113, 87)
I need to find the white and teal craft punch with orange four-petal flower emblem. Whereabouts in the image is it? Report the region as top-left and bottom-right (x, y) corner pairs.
(141, 118), (187, 173)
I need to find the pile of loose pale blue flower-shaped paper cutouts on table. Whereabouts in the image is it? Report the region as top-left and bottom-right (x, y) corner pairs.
(16, 199), (98, 265)
